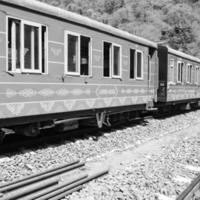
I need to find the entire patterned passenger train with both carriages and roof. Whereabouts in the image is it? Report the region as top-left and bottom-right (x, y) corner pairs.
(0, 0), (200, 141)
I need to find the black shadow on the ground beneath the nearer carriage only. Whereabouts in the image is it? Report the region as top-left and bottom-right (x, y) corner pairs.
(0, 118), (148, 155)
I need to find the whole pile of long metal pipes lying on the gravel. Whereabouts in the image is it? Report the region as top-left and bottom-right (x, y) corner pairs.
(0, 160), (108, 200)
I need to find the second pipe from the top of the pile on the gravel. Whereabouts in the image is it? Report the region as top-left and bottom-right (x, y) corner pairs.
(0, 163), (85, 193)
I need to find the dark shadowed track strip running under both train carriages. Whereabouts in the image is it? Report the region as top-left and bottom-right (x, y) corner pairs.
(0, 109), (194, 155)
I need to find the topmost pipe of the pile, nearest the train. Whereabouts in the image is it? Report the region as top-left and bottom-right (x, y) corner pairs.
(0, 160), (80, 191)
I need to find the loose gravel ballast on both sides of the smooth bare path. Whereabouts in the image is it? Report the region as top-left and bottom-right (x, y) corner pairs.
(0, 111), (200, 200)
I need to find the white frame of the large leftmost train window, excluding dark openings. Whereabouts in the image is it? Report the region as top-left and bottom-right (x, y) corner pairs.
(6, 15), (48, 74)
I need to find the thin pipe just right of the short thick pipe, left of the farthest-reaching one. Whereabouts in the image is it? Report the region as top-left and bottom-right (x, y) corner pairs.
(19, 174), (88, 200)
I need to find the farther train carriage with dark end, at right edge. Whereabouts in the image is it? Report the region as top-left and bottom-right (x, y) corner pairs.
(158, 45), (200, 106)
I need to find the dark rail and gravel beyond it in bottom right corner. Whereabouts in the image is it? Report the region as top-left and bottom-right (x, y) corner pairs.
(176, 174), (200, 200)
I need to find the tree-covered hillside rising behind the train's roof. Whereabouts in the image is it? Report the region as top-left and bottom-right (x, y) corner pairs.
(36, 0), (200, 57)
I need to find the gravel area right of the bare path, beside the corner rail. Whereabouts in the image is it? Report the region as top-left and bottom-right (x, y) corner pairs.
(65, 137), (200, 200)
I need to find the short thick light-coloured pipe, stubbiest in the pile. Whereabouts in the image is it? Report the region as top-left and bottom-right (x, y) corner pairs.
(0, 177), (59, 200)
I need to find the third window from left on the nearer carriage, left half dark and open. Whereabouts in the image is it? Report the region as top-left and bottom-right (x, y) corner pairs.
(103, 42), (121, 78)
